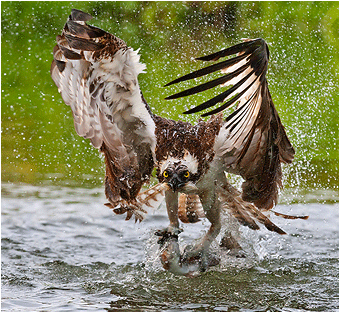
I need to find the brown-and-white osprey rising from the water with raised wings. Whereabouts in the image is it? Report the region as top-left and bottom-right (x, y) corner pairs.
(51, 10), (306, 275)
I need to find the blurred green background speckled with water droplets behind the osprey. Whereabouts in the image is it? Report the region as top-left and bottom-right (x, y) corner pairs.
(1, 1), (339, 197)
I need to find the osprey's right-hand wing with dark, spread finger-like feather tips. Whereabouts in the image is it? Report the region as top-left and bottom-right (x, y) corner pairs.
(167, 38), (295, 210)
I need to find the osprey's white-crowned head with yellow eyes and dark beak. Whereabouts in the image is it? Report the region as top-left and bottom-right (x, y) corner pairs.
(158, 152), (198, 192)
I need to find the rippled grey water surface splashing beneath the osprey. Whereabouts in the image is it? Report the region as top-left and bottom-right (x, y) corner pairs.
(1, 184), (339, 311)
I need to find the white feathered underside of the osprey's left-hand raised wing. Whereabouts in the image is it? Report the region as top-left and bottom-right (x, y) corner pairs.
(52, 44), (156, 158)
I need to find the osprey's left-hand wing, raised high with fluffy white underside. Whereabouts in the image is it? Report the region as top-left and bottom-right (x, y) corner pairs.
(51, 10), (156, 219)
